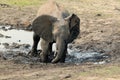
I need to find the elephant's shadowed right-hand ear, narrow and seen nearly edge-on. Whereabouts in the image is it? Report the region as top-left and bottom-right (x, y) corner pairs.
(65, 14), (80, 43)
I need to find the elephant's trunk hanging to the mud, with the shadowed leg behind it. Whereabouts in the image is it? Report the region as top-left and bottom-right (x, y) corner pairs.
(52, 38), (67, 63)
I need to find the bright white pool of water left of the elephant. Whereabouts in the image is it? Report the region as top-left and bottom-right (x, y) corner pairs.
(0, 25), (33, 45)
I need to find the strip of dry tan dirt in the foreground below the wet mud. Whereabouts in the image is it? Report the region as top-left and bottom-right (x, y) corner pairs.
(0, 60), (120, 80)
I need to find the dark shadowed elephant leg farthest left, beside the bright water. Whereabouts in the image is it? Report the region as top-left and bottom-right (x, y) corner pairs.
(29, 33), (40, 57)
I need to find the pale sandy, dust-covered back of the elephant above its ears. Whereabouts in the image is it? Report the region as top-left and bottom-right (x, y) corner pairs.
(37, 0), (69, 19)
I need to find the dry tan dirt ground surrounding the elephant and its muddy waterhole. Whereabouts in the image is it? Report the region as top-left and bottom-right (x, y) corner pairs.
(0, 0), (120, 80)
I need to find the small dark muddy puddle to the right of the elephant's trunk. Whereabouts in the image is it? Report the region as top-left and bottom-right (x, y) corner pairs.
(66, 49), (110, 64)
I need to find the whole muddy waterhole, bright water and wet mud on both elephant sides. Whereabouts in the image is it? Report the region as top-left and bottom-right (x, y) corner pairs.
(0, 26), (109, 64)
